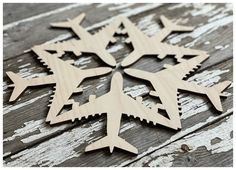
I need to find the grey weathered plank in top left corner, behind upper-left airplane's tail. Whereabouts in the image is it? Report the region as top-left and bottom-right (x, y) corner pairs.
(3, 4), (162, 59)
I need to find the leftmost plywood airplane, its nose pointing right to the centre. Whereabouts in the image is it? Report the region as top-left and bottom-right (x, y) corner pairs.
(6, 46), (112, 122)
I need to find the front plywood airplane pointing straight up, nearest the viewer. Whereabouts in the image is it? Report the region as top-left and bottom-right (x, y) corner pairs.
(50, 72), (177, 154)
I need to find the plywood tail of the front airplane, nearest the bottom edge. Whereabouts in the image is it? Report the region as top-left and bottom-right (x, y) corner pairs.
(85, 136), (138, 154)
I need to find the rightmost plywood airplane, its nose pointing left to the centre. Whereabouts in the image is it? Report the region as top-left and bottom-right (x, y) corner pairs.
(124, 55), (231, 128)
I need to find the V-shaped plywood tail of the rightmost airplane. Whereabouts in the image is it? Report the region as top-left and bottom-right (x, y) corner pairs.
(206, 81), (231, 112)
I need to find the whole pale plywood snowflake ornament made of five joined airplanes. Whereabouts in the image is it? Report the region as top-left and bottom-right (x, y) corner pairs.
(7, 14), (231, 154)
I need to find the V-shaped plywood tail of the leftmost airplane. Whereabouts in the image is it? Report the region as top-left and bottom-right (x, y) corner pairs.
(6, 71), (28, 102)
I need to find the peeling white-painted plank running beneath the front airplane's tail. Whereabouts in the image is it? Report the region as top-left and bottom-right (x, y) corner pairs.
(5, 60), (232, 166)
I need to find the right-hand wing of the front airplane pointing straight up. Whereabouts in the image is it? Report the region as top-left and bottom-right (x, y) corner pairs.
(122, 95), (177, 129)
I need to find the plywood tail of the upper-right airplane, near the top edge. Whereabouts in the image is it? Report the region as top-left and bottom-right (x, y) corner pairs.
(160, 15), (194, 32)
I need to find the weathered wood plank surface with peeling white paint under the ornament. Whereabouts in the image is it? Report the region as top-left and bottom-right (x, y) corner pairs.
(3, 4), (233, 166)
